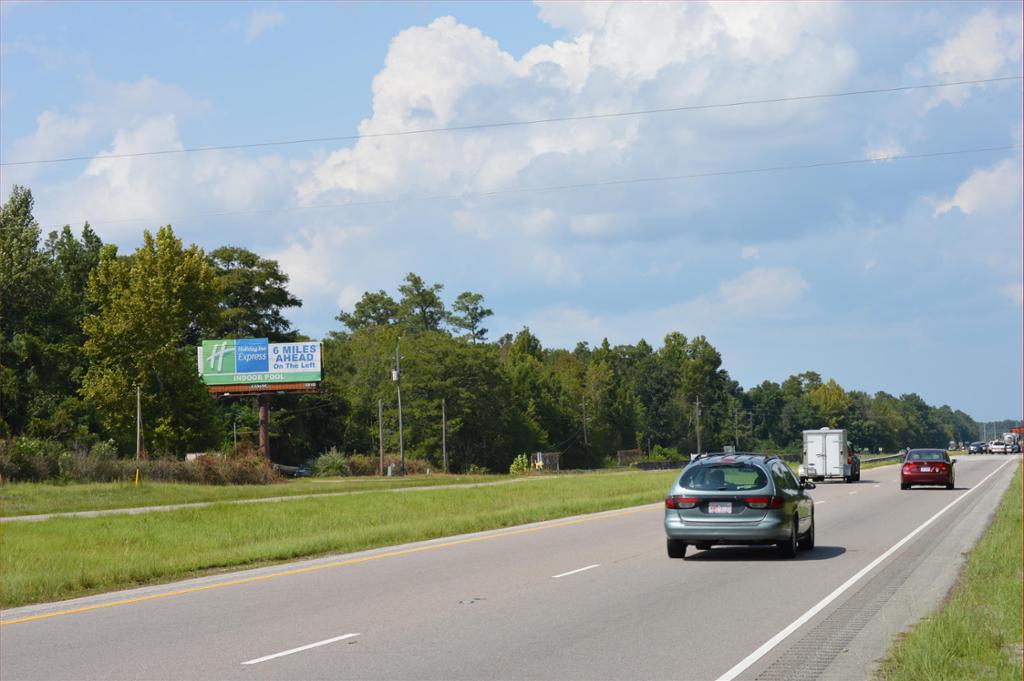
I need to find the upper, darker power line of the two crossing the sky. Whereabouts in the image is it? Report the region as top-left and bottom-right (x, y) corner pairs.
(0, 76), (1024, 167)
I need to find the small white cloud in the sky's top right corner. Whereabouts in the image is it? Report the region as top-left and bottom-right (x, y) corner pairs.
(928, 9), (1024, 105)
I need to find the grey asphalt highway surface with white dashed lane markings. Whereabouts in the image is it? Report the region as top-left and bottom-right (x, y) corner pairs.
(0, 456), (1020, 681)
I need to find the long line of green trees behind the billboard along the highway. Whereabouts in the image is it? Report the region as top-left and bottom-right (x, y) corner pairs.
(0, 186), (982, 471)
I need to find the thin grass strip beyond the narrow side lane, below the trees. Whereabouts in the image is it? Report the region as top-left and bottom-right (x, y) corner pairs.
(0, 475), (508, 517)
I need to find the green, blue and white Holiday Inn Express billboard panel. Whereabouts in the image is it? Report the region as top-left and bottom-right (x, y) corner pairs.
(196, 338), (323, 386)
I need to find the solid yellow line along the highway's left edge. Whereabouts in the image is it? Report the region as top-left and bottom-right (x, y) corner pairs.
(0, 504), (651, 627)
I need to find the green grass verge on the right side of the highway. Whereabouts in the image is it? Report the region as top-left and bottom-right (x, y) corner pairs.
(881, 458), (1024, 681)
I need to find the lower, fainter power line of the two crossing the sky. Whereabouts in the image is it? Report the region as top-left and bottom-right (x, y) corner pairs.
(36, 144), (1024, 228)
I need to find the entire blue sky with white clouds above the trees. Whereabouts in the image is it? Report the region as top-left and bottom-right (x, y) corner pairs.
(0, 0), (1024, 421)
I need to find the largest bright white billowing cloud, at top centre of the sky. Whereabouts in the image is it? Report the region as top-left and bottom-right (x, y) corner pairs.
(299, 3), (856, 209)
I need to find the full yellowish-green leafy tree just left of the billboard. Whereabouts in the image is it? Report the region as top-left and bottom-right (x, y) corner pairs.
(82, 225), (220, 454)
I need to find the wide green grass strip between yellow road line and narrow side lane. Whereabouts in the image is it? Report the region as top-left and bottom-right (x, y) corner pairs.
(0, 471), (678, 607)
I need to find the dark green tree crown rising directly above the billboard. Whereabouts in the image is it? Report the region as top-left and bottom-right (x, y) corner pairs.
(208, 246), (302, 342)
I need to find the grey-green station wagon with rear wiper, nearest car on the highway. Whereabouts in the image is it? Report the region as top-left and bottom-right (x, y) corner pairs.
(665, 454), (814, 558)
